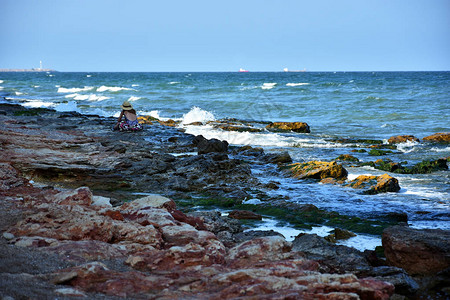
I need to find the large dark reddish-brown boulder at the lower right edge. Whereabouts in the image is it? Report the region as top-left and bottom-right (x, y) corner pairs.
(382, 226), (450, 275)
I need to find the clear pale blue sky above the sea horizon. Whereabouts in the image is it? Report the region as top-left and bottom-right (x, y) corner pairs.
(0, 0), (450, 72)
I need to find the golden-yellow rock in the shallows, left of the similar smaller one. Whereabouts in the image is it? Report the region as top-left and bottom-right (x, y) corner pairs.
(289, 161), (348, 180)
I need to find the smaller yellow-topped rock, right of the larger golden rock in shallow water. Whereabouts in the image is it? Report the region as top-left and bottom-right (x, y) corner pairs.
(347, 174), (400, 195)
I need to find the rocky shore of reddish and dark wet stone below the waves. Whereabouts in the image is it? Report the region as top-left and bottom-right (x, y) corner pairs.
(0, 104), (450, 299)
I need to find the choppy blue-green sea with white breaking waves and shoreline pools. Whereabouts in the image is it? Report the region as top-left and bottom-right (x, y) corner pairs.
(0, 72), (450, 250)
